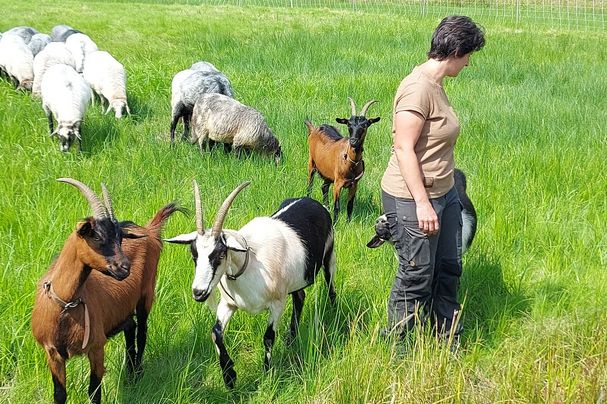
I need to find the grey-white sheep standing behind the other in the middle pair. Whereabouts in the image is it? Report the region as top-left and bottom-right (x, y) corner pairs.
(171, 62), (234, 143)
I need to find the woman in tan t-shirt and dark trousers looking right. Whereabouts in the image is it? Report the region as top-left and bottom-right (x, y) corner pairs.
(381, 16), (485, 339)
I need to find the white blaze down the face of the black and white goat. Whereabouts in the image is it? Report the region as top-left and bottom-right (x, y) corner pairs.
(192, 234), (227, 301)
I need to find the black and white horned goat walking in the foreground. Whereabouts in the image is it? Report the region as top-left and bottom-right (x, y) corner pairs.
(165, 181), (336, 388)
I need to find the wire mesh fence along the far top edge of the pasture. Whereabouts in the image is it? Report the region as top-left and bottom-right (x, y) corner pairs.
(140, 0), (607, 30)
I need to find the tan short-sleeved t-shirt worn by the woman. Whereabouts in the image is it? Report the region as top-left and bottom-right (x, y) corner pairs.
(381, 66), (460, 199)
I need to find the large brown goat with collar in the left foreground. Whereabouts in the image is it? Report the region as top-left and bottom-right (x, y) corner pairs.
(32, 179), (179, 403)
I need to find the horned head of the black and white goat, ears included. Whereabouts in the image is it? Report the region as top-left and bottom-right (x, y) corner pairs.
(164, 180), (250, 302)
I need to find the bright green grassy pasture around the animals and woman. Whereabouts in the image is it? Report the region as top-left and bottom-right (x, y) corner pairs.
(0, 0), (607, 403)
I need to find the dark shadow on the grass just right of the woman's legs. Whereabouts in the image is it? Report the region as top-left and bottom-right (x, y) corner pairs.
(460, 254), (530, 346)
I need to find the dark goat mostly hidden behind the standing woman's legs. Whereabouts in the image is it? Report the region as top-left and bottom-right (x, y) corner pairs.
(367, 168), (477, 254)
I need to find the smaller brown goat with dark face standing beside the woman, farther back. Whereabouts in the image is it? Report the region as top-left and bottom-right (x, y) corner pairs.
(305, 97), (380, 222)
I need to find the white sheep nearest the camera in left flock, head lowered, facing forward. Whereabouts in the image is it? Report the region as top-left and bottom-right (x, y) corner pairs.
(41, 65), (91, 152)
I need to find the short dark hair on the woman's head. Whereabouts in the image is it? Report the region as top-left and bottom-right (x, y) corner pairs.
(428, 15), (485, 60)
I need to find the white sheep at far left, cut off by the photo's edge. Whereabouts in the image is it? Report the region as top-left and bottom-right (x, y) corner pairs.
(0, 34), (34, 90)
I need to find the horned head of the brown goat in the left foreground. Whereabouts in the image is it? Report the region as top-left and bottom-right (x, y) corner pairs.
(57, 178), (143, 281)
